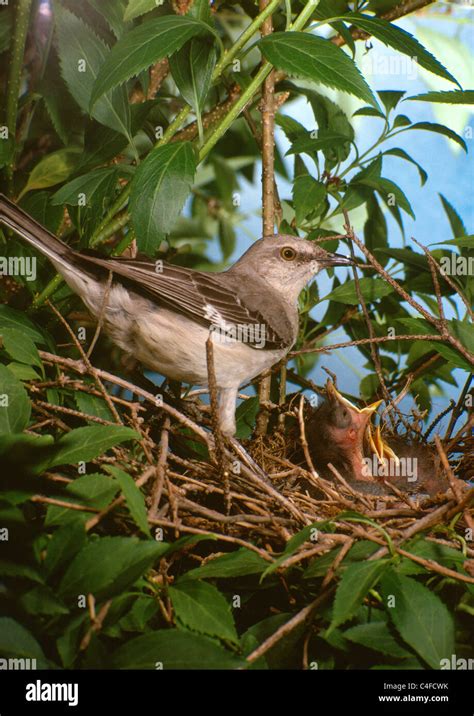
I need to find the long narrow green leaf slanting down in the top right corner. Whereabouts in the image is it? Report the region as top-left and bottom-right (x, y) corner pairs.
(344, 13), (459, 84)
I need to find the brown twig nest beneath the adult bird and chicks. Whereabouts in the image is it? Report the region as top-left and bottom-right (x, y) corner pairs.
(30, 352), (474, 581)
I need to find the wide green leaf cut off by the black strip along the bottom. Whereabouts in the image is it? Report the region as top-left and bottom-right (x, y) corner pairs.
(112, 629), (246, 671)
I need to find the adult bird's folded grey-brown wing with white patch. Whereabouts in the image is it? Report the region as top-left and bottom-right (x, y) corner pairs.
(80, 254), (293, 350)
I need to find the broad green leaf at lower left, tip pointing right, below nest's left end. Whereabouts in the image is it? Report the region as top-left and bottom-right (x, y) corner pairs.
(58, 537), (168, 601)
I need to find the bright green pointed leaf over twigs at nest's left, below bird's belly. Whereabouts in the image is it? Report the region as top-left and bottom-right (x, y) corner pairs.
(51, 425), (140, 466)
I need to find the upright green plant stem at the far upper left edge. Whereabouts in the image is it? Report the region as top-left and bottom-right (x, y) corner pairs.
(6, 0), (31, 196)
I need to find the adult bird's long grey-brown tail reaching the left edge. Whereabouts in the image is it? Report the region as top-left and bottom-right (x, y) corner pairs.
(0, 194), (74, 265)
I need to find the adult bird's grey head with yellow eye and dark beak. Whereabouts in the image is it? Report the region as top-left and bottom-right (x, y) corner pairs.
(231, 234), (353, 303)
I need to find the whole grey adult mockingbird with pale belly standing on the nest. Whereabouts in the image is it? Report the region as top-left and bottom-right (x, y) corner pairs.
(0, 195), (352, 435)
